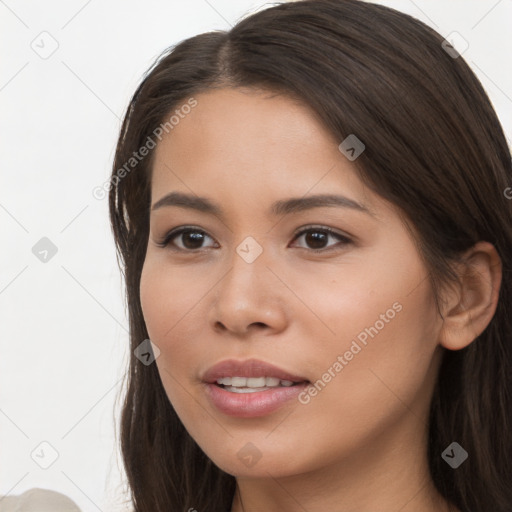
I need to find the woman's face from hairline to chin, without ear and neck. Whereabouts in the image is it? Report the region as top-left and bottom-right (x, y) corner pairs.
(140, 89), (441, 477)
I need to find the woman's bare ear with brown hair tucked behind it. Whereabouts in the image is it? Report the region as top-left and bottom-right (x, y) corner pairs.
(439, 242), (502, 350)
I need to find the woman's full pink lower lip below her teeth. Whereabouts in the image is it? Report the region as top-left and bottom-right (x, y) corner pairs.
(205, 382), (308, 418)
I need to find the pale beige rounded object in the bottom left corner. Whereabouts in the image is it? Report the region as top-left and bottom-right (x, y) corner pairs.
(0, 489), (81, 512)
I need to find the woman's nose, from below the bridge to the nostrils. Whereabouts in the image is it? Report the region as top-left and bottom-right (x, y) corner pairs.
(210, 246), (290, 337)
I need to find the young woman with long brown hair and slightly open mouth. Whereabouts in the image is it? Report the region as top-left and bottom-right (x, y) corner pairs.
(110, 0), (512, 512)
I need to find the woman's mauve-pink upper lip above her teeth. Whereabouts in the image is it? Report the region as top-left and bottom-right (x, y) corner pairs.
(202, 359), (308, 384)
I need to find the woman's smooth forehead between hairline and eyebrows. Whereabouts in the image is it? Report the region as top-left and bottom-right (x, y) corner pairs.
(152, 88), (378, 216)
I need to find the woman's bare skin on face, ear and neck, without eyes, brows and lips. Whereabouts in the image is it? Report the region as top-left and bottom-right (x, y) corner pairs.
(140, 88), (501, 512)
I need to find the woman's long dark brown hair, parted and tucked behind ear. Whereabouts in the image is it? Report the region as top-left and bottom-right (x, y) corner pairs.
(109, 0), (512, 512)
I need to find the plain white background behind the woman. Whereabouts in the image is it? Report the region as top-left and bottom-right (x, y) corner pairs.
(0, 0), (512, 512)
